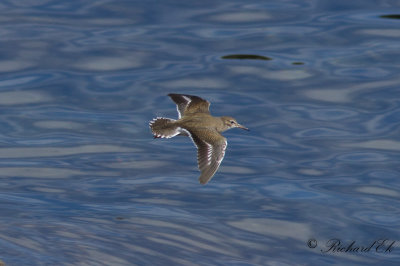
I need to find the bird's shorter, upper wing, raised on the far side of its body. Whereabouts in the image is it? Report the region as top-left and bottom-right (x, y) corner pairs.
(168, 93), (210, 118)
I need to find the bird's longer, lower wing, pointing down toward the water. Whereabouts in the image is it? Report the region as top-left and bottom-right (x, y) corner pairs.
(189, 129), (228, 185)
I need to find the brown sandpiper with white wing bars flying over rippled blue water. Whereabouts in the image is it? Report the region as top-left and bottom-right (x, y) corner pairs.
(150, 93), (249, 185)
